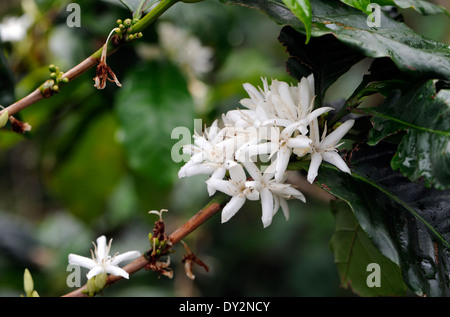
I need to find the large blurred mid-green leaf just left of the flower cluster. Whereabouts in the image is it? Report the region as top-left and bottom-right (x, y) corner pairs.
(115, 62), (194, 187)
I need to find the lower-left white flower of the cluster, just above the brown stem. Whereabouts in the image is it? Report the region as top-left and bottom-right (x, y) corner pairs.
(206, 164), (259, 222)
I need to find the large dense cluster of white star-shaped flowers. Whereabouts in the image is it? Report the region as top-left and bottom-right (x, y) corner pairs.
(178, 75), (354, 227)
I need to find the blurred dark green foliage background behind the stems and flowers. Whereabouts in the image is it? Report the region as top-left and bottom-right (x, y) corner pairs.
(0, 0), (450, 296)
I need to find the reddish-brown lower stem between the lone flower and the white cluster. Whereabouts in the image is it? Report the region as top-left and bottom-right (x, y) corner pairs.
(63, 196), (226, 297)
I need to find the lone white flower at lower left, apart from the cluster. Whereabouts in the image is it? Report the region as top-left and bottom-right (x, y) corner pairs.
(69, 236), (141, 279)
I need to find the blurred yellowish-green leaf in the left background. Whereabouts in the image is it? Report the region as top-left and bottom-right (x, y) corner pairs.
(50, 114), (124, 222)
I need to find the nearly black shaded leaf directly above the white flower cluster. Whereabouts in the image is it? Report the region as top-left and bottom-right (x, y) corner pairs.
(279, 26), (364, 104)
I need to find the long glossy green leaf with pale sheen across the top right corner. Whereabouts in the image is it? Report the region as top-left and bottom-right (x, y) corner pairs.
(223, 0), (450, 79)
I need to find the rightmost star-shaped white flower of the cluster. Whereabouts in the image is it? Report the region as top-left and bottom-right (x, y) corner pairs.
(307, 119), (355, 184)
